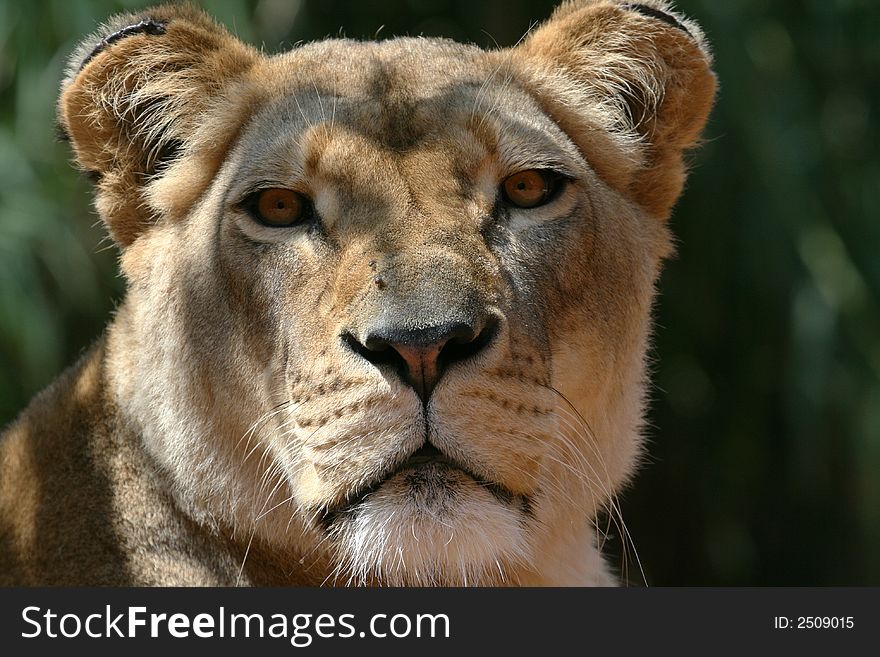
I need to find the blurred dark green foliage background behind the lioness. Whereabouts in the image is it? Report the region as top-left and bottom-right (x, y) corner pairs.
(0, 0), (880, 585)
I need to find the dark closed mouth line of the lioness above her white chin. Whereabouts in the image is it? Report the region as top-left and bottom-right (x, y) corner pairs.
(317, 441), (532, 529)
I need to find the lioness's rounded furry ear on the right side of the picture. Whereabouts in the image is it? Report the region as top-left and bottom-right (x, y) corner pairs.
(515, 0), (715, 218)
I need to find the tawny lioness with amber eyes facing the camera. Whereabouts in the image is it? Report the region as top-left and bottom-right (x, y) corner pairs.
(0, 0), (715, 585)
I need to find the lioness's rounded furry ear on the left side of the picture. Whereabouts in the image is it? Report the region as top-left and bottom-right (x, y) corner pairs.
(58, 5), (259, 246)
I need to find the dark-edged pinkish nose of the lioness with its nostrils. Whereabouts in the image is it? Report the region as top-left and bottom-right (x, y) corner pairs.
(343, 320), (497, 402)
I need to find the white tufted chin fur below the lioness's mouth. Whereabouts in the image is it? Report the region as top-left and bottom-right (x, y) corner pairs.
(330, 475), (530, 586)
